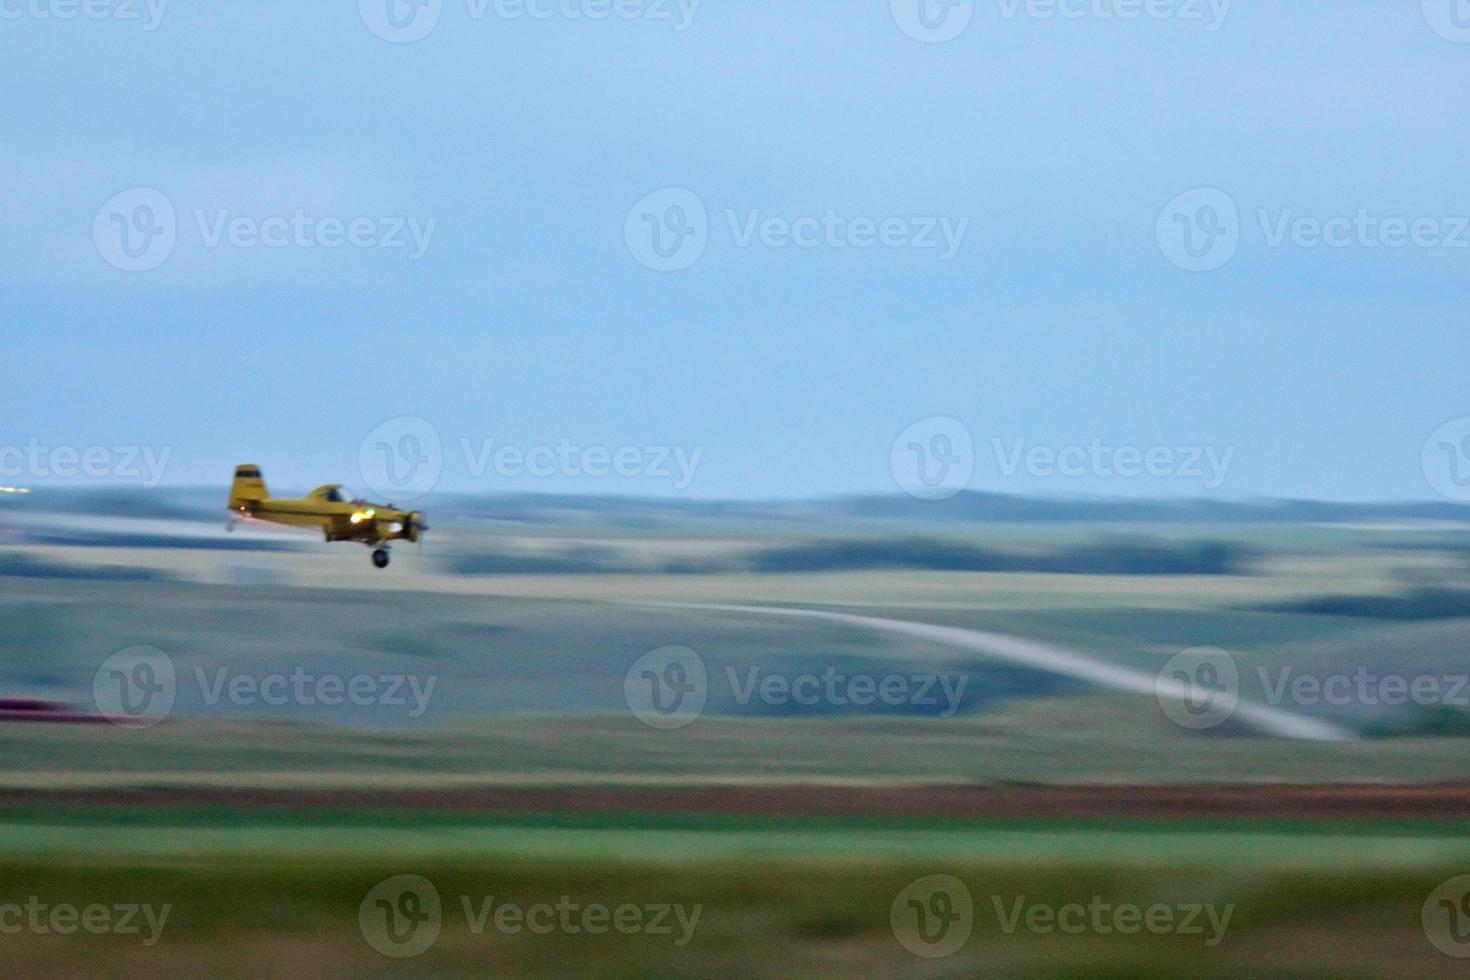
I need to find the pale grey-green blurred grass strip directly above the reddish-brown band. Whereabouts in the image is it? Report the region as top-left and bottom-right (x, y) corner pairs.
(0, 708), (1470, 788)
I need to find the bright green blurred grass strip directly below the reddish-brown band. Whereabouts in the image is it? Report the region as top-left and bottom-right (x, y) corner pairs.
(0, 804), (1470, 873)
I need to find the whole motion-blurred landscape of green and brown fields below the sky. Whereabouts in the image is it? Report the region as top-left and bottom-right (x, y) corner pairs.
(0, 489), (1470, 977)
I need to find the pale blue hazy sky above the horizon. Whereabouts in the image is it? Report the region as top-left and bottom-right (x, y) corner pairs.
(0, 0), (1470, 500)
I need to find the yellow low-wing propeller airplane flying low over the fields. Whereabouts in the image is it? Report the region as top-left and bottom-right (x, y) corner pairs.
(226, 463), (429, 569)
